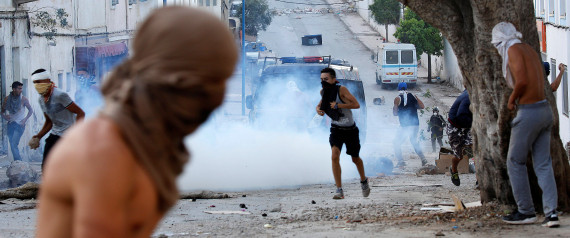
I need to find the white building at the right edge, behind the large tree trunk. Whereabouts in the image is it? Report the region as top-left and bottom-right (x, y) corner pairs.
(534, 0), (570, 148)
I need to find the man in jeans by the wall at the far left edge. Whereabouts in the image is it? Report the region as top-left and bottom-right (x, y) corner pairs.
(1, 81), (34, 160)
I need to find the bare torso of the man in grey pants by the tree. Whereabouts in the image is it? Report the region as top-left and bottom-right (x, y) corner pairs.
(508, 43), (545, 104)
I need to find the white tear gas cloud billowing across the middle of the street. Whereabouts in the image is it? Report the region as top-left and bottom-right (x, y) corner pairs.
(178, 69), (358, 191)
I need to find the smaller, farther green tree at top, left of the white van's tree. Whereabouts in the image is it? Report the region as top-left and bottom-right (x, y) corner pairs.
(368, 0), (400, 40)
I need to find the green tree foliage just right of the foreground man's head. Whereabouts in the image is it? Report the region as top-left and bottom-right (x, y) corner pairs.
(236, 0), (273, 36)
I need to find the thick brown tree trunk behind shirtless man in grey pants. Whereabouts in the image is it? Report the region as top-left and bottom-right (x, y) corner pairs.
(399, 0), (570, 212)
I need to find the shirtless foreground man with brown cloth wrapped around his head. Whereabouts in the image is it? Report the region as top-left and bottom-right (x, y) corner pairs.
(37, 7), (237, 237)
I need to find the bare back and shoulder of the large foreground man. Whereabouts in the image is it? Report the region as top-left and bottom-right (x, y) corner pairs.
(37, 117), (163, 237)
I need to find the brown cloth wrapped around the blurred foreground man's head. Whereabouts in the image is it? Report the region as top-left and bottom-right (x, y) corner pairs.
(102, 7), (237, 212)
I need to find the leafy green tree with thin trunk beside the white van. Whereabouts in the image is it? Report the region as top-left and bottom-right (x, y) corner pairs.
(394, 8), (443, 83)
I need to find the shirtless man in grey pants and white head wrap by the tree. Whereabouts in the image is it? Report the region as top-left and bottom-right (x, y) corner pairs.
(491, 22), (560, 227)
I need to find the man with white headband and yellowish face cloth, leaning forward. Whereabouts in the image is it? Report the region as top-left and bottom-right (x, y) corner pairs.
(29, 69), (85, 170)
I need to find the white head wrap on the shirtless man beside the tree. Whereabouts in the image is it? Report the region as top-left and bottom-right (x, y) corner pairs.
(491, 22), (522, 88)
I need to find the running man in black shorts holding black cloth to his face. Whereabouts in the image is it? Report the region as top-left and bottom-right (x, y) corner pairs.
(316, 68), (370, 199)
